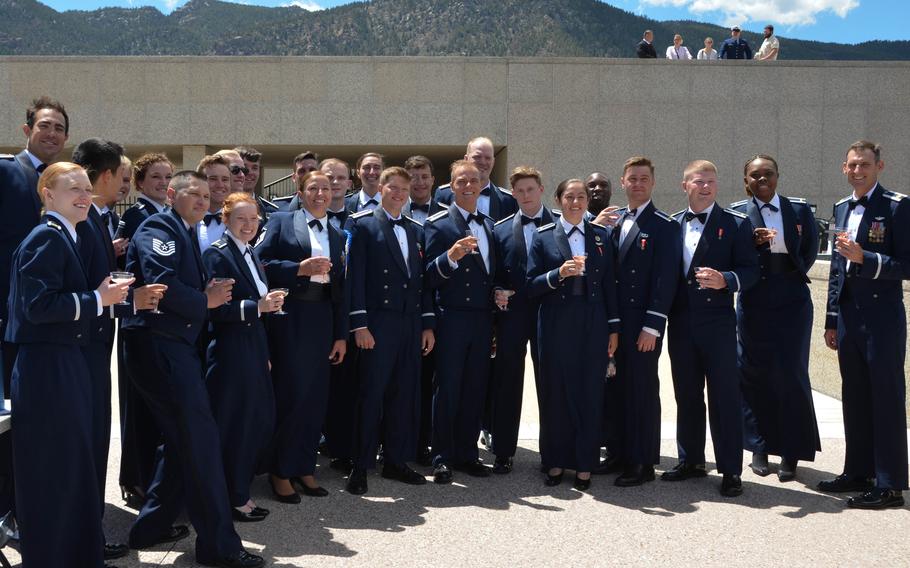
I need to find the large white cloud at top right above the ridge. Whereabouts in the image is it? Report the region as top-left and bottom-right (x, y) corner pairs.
(640, 0), (859, 26)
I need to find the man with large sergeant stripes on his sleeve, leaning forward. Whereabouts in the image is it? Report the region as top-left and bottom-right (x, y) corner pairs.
(123, 171), (263, 568)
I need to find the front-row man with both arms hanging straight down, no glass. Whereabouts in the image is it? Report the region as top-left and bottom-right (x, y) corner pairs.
(347, 167), (436, 495)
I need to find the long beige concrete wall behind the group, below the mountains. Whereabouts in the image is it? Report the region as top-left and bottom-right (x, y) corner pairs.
(0, 57), (910, 217)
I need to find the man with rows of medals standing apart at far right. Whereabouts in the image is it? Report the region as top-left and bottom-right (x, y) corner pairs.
(818, 140), (910, 509)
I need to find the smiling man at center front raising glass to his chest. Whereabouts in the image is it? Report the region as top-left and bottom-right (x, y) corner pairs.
(424, 160), (496, 483)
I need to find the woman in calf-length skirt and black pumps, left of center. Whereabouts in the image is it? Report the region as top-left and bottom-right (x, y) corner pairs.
(256, 171), (348, 503)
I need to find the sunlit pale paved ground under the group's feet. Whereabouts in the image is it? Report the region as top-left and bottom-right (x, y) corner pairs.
(1, 352), (910, 568)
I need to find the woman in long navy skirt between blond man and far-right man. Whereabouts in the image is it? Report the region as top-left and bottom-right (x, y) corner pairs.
(731, 154), (821, 481)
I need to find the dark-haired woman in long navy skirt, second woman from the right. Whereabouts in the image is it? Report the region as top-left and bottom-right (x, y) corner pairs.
(527, 179), (620, 490)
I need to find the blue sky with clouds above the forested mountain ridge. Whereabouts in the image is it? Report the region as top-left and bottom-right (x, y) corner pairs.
(43, 0), (910, 43)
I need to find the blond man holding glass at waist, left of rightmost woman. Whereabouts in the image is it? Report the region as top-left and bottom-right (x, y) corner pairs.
(661, 160), (760, 497)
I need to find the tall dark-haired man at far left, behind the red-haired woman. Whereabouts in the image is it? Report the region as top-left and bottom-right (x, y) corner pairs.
(0, 97), (69, 516)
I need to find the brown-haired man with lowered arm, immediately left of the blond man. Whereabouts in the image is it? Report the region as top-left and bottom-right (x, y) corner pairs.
(607, 156), (682, 487)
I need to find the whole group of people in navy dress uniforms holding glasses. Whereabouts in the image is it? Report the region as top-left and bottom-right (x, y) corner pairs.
(0, 98), (910, 567)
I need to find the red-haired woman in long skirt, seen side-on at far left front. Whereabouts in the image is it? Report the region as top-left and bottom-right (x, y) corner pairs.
(5, 162), (131, 568)
